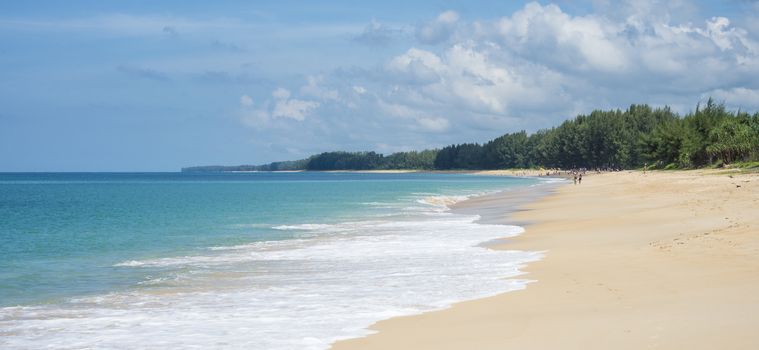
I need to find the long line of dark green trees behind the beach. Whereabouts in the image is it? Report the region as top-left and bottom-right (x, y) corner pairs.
(183, 99), (759, 171)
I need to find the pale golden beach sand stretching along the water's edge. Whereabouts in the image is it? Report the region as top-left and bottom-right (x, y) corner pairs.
(333, 171), (759, 349)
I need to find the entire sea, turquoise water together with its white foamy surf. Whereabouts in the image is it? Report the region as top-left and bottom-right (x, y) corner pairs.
(0, 172), (542, 349)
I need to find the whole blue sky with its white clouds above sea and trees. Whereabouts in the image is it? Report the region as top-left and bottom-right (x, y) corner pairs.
(0, 0), (759, 171)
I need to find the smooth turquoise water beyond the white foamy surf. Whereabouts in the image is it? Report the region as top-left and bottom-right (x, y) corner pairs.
(0, 173), (530, 306)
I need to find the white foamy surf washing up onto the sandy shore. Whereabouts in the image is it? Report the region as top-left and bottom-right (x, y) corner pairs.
(0, 196), (541, 349)
